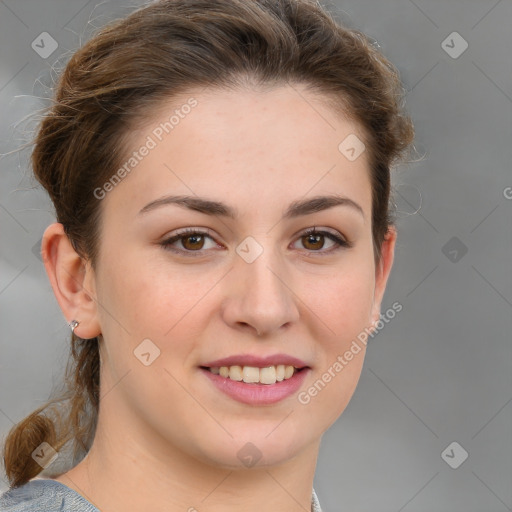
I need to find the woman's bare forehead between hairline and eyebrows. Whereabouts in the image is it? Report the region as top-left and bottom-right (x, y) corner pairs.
(103, 86), (371, 220)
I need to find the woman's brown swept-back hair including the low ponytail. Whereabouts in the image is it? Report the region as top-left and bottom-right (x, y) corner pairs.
(4, 0), (413, 487)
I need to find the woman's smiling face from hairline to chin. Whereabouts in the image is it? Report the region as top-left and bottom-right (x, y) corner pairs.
(87, 86), (394, 467)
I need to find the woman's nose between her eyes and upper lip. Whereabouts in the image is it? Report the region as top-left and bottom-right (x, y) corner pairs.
(222, 243), (299, 336)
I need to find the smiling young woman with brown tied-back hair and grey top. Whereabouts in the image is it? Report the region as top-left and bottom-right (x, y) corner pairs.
(0, 0), (413, 512)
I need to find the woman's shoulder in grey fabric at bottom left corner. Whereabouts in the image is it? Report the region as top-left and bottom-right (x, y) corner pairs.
(0, 479), (99, 512)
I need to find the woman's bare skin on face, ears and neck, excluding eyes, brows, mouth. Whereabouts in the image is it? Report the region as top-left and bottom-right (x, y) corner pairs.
(43, 86), (396, 512)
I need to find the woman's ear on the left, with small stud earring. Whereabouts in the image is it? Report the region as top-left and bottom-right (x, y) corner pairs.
(41, 223), (101, 338)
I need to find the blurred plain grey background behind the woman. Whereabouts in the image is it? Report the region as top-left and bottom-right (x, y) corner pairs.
(0, 0), (512, 512)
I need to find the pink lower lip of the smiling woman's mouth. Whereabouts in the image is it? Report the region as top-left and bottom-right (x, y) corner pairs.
(200, 368), (310, 405)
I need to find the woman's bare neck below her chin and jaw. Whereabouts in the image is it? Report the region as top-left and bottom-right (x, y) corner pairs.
(55, 400), (320, 512)
